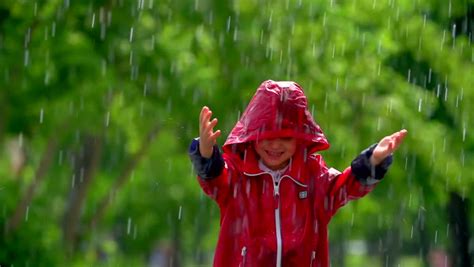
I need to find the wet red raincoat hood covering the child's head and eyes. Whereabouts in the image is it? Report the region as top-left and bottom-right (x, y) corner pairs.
(223, 80), (329, 154)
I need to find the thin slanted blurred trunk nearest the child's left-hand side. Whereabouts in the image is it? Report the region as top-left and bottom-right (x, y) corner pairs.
(91, 125), (160, 228)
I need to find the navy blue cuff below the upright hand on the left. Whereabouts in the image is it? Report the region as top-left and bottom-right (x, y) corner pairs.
(188, 138), (224, 179)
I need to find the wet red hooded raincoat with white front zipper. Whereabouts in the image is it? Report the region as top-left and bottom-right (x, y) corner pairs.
(198, 80), (380, 267)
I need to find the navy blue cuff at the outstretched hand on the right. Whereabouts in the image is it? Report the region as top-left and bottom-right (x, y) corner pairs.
(351, 144), (393, 185)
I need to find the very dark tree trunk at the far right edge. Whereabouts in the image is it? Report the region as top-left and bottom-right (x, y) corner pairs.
(447, 192), (472, 267)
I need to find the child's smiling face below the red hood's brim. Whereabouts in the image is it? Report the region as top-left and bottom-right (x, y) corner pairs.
(255, 137), (296, 170)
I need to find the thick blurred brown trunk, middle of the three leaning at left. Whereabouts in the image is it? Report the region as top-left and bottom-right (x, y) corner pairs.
(63, 136), (102, 253)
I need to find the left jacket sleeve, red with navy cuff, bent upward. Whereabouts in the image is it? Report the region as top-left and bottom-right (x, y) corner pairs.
(188, 138), (232, 205)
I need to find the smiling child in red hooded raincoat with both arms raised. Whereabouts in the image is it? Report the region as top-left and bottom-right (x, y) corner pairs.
(189, 80), (407, 267)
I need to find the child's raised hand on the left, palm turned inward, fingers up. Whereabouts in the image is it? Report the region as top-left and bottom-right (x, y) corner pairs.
(199, 106), (221, 158)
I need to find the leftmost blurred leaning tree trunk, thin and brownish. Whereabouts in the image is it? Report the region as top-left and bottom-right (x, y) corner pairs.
(6, 135), (57, 233)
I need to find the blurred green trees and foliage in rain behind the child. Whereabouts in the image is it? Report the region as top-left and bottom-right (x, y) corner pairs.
(0, 0), (474, 267)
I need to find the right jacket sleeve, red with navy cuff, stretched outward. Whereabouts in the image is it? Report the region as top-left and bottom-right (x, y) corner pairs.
(314, 144), (393, 218)
